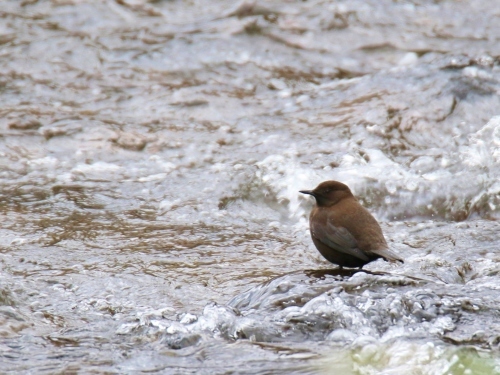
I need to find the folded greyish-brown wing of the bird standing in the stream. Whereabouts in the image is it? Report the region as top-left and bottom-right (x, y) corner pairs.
(311, 222), (370, 262)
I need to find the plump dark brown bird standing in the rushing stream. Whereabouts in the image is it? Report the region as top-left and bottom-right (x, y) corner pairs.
(300, 181), (403, 268)
